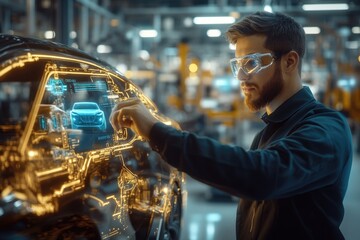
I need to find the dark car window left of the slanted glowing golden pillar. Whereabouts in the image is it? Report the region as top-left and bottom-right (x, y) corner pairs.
(0, 55), (45, 145)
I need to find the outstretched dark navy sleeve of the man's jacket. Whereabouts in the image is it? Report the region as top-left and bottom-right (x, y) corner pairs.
(150, 117), (351, 200)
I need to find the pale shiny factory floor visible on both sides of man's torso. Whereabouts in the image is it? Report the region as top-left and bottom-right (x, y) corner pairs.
(181, 124), (360, 240)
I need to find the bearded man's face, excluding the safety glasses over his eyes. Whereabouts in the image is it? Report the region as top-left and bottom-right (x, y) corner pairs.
(235, 35), (284, 111)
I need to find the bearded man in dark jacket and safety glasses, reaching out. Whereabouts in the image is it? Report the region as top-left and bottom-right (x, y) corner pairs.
(110, 12), (352, 240)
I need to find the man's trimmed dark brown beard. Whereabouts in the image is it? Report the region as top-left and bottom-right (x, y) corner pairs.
(245, 64), (284, 111)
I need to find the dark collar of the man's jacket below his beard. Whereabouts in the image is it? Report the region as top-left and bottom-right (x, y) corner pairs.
(261, 87), (315, 124)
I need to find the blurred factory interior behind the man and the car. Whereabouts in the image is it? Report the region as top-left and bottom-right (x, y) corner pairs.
(0, 0), (360, 240)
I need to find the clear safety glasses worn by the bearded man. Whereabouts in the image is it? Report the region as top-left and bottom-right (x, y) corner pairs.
(230, 53), (275, 78)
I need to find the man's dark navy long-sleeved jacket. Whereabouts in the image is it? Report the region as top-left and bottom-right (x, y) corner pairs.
(150, 87), (352, 240)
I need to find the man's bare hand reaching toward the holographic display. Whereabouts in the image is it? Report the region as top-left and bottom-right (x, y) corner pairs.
(110, 98), (158, 140)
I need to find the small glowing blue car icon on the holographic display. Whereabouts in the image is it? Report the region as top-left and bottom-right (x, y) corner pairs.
(70, 102), (106, 131)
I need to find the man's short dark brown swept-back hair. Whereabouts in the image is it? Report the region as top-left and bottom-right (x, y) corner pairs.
(226, 11), (305, 59)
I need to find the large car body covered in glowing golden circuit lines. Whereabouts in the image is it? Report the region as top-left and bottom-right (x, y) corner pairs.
(0, 35), (184, 240)
